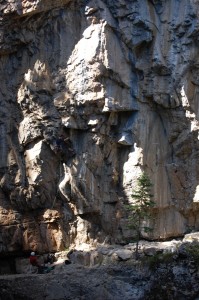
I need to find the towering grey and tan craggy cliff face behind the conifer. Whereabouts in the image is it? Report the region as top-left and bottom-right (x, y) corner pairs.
(0, 0), (199, 253)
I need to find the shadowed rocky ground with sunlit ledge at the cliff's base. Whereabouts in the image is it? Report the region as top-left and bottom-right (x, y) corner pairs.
(0, 233), (199, 300)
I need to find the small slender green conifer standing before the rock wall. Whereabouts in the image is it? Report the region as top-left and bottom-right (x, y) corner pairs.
(126, 172), (155, 259)
